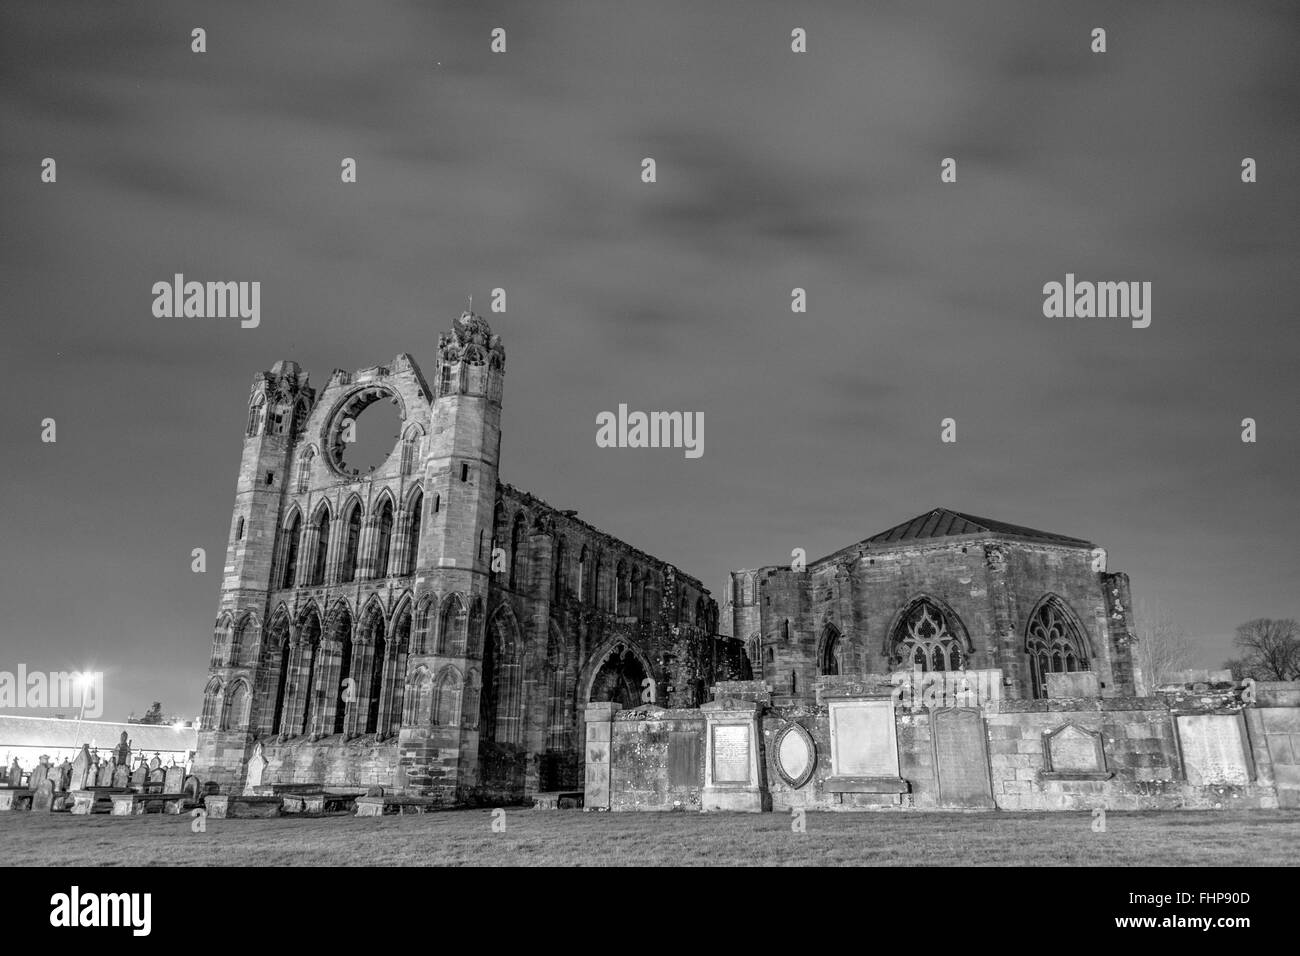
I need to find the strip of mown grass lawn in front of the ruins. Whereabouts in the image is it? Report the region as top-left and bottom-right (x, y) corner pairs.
(0, 809), (1300, 866)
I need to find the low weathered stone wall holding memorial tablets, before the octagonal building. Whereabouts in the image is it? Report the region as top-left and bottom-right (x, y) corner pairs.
(588, 682), (1300, 813)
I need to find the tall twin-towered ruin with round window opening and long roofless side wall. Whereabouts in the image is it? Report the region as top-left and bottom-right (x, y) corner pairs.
(196, 312), (749, 804)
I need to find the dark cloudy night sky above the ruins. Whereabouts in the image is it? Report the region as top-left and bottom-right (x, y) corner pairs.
(0, 0), (1300, 718)
